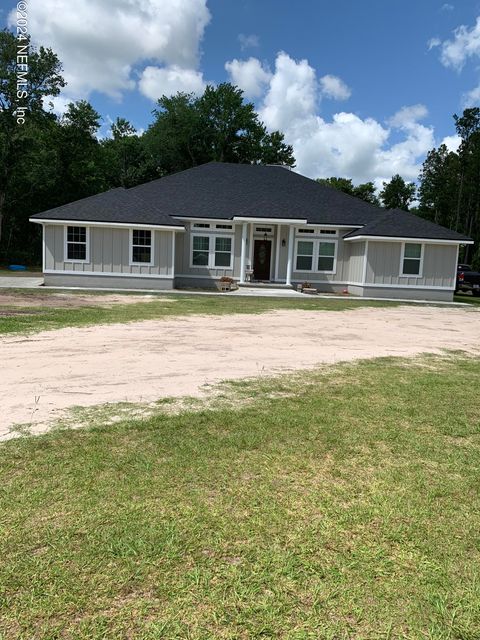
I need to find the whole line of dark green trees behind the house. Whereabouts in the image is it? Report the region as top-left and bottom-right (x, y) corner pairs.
(0, 30), (480, 267)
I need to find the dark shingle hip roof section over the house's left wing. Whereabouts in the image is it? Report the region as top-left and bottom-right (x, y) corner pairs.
(31, 187), (183, 227)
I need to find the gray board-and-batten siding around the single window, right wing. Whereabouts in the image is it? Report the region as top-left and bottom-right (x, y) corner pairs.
(364, 239), (457, 289)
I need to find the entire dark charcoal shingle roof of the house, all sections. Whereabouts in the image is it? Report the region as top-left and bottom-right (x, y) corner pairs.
(32, 162), (469, 242)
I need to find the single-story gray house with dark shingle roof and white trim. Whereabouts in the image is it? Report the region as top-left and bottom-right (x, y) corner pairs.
(31, 162), (472, 300)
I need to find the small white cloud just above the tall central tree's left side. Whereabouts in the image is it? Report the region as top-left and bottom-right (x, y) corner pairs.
(138, 65), (206, 101)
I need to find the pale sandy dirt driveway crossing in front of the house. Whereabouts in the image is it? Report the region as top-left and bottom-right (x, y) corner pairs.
(0, 306), (480, 439)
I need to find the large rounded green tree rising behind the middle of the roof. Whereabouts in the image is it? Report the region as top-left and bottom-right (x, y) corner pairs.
(144, 83), (295, 178)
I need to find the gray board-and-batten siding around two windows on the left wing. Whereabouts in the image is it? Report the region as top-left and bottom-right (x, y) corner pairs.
(44, 224), (173, 277)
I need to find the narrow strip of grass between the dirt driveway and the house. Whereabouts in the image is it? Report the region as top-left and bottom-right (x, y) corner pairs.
(0, 290), (396, 334)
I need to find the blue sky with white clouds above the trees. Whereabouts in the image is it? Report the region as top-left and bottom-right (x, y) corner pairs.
(0, 0), (480, 186)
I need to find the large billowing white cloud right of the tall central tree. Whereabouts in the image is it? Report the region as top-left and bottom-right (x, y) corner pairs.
(260, 53), (435, 186)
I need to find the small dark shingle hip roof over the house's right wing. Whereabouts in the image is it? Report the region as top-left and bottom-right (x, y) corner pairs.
(345, 209), (470, 242)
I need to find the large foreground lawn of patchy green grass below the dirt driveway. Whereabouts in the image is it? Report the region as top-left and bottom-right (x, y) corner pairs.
(0, 357), (480, 640)
